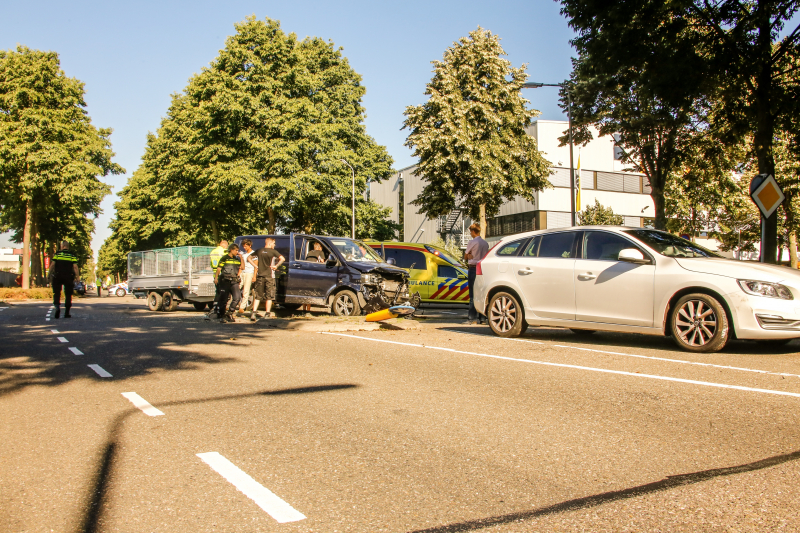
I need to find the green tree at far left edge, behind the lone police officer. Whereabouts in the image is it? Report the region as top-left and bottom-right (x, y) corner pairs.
(0, 46), (124, 288)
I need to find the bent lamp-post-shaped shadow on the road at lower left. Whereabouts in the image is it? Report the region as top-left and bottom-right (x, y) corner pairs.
(77, 383), (359, 533)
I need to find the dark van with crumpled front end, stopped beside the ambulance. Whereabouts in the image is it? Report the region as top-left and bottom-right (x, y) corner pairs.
(235, 233), (419, 316)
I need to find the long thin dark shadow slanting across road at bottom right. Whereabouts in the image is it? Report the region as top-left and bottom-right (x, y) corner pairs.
(409, 450), (800, 533)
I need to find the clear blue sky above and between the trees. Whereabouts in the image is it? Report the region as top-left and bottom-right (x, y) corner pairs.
(0, 0), (572, 253)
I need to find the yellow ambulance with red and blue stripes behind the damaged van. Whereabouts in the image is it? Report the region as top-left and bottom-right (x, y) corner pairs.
(368, 241), (469, 304)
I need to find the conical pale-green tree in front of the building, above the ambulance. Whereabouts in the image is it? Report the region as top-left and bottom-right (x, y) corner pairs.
(403, 27), (550, 236)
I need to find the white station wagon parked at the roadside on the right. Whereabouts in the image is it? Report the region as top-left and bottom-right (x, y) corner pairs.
(474, 226), (800, 352)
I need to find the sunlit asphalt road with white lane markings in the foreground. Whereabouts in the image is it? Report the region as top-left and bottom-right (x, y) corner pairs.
(0, 297), (800, 533)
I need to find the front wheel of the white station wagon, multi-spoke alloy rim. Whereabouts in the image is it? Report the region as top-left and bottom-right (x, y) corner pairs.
(670, 293), (730, 352)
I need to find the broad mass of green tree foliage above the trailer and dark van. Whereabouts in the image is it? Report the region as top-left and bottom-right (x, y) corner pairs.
(101, 17), (396, 268)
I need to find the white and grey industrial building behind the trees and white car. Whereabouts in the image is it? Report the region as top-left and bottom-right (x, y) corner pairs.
(369, 120), (654, 247)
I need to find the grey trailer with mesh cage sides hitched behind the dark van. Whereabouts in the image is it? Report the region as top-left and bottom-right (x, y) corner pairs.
(128, 246), (215, 311)
